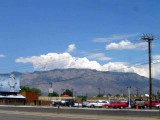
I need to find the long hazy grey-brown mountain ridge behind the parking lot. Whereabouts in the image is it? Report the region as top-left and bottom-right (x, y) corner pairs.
(0, 69), (160, 96)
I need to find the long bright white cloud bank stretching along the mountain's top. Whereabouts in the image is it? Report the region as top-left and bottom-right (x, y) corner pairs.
(16, 52), (160, 77)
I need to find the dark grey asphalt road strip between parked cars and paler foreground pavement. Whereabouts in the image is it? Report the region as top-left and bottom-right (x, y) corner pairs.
(0, 105), (160, 117)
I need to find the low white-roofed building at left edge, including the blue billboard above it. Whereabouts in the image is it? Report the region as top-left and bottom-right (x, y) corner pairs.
(0, 74), (26, 105)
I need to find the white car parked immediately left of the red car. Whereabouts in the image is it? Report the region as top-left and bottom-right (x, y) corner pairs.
(87, 100), (109, 108)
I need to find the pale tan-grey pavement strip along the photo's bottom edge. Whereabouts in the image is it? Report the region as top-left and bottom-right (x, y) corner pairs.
(0, 110), (159, 120)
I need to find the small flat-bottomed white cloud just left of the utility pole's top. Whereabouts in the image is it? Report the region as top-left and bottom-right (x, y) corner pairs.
(106, 40), (147, 50)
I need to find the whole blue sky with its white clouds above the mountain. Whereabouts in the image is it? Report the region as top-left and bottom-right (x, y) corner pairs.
(0, 0), (160, 79)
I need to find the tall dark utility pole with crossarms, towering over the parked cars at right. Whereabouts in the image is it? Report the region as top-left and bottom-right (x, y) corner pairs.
(141, 35), (154, 109)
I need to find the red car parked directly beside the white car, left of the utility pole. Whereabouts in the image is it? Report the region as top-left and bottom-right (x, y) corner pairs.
(103, 101), (128, 109)
